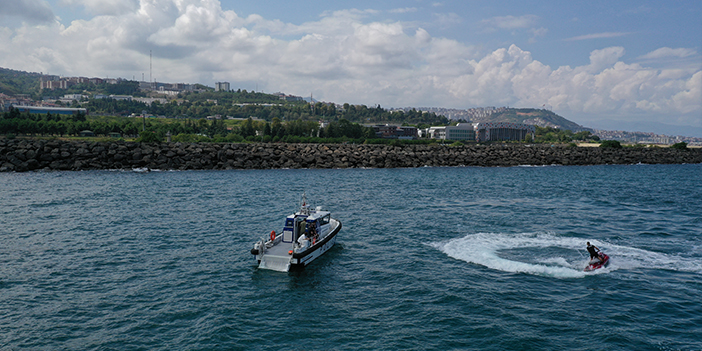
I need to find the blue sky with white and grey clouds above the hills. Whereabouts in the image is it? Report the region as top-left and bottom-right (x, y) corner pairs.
(0, 0), (702, 137)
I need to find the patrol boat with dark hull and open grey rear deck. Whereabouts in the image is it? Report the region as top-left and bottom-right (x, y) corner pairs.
(251, 193), (341, 272)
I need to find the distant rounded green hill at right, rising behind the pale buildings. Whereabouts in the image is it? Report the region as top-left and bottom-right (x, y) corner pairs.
(490, 108), (593, 133)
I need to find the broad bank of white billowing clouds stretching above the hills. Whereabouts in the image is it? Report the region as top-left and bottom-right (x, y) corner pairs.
(0, 0), (702, 129)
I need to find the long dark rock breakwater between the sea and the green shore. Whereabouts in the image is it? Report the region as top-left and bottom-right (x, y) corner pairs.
(0, 139), (702, 172)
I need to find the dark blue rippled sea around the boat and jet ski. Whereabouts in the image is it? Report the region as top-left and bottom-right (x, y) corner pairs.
(0, 164), (702, 350)
